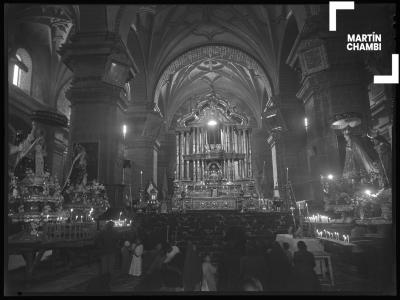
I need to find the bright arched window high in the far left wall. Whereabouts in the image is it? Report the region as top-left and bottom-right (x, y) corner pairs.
(12, 48), (32, 94)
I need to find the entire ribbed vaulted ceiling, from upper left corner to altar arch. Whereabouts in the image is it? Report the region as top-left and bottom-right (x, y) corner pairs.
(8, 5), (309, 126)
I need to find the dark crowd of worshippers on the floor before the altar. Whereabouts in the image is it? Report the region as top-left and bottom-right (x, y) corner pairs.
(91, 212), (320, 293)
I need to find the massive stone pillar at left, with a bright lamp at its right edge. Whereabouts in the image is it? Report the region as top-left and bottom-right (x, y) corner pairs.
(59, 32), (135, 206)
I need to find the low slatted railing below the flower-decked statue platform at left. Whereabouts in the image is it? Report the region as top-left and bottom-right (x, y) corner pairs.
(43, 223), (96, 241)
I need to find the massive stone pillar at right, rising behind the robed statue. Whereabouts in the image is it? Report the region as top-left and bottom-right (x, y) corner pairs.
(288, 15), (371, 181)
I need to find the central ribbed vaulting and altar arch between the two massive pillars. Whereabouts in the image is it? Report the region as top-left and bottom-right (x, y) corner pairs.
(122, 5), (304, 126)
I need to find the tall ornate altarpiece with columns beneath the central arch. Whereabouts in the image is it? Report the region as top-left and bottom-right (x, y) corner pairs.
(173, 91), (258, 210)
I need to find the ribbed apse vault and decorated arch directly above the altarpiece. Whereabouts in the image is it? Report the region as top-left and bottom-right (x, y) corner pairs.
(154, 45), (271, 126)
